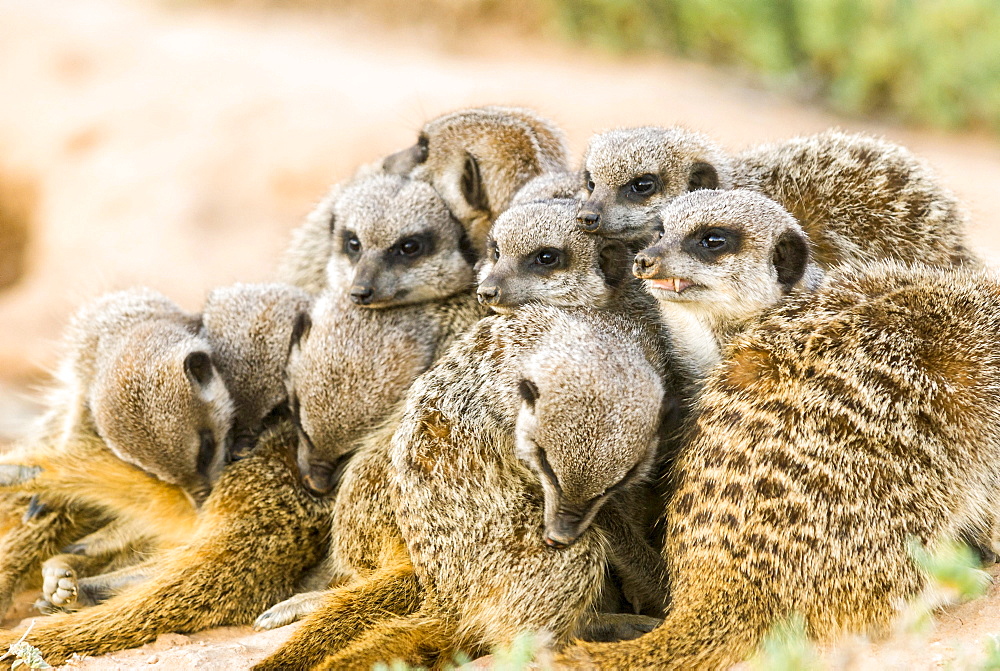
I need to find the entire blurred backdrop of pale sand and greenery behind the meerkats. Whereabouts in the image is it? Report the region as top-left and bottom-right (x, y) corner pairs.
(0, 0), (1000, 441)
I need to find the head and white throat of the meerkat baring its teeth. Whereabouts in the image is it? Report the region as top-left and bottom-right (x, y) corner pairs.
(634, 189), (823, 379)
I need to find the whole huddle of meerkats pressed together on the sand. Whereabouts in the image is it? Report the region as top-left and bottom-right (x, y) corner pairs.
(0, 107), (1000, 670)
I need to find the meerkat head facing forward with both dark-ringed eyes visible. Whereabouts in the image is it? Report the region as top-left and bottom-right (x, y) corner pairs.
(327, 175), (475, 308)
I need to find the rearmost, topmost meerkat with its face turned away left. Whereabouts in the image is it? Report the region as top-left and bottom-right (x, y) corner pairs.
(383, 106), (568, 254)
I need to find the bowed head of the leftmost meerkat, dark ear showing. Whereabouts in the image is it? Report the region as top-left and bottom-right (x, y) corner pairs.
(88, 320), (233, 503)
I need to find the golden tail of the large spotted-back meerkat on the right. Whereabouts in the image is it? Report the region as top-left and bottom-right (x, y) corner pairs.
(555, 567), (775, 671)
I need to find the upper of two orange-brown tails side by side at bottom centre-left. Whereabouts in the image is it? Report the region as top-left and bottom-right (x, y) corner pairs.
(254, 557), (421, 671)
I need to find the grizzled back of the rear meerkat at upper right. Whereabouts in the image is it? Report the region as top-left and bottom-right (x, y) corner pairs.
(734, 130), (976, 268)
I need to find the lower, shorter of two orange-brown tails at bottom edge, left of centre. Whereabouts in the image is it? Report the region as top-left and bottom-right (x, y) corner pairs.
(315, 610), (455, 671)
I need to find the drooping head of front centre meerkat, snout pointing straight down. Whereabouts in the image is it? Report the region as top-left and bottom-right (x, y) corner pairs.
(515, 317), (664, 548)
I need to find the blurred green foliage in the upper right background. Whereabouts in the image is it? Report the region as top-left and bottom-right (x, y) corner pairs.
(547, 0), (1000, 131)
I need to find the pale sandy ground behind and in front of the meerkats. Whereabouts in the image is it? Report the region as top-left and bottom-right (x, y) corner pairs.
(0, 0), (1000, 669)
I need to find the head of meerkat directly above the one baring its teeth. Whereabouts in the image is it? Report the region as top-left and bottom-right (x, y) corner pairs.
(579, 126), (732, 242)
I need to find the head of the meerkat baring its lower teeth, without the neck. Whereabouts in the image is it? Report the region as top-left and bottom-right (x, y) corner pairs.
(633, 190), (809, 321)
